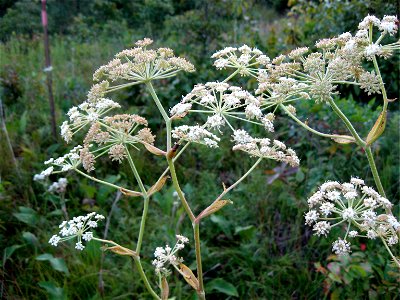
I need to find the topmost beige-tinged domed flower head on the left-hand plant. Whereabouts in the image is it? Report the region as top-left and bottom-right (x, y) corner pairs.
(93, 38), (195, 83)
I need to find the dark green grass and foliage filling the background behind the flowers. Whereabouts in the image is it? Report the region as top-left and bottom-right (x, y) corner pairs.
(0, 0), (400, 299)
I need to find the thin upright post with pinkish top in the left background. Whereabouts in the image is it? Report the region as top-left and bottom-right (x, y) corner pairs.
(42, 0), (57, 140)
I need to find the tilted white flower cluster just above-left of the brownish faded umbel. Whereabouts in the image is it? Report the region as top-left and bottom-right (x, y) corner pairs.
(61, 98), (121, 143)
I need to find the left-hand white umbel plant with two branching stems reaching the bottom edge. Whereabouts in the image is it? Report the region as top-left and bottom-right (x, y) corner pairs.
(37, 38), (300, 299)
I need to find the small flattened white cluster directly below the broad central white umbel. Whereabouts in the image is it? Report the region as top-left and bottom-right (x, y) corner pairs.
(172, 125), (220, 148)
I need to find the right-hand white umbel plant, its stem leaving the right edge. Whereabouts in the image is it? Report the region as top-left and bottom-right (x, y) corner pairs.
(214, 15), (400, 268)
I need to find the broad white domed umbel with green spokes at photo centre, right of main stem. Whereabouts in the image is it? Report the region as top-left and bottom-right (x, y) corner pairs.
(170, 82), (274, 132)
